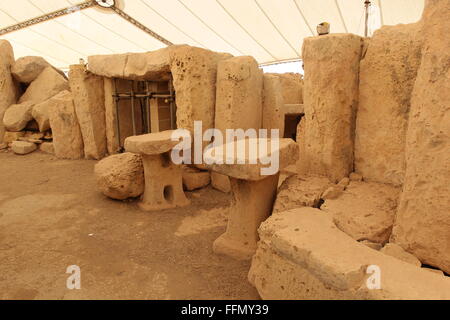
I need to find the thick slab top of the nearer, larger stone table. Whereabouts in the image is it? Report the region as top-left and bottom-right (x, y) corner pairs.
(204, 138), (299, 181)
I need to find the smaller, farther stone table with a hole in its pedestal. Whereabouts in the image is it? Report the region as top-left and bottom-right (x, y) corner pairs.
(125, 130), (190, 211)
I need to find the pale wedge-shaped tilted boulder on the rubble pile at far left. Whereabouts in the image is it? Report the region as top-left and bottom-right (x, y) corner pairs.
(19, 67), (69, 104)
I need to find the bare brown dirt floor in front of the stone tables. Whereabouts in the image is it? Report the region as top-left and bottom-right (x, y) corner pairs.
(0, 151), (259, 299)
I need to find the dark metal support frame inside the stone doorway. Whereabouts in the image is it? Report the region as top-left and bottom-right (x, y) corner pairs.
(112, 78), (176, 152)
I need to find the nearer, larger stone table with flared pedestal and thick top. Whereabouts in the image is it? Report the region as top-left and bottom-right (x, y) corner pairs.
(205, 138), (299, 260)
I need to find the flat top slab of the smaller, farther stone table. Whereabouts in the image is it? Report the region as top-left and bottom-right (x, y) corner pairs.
(125, 130), (179, 155)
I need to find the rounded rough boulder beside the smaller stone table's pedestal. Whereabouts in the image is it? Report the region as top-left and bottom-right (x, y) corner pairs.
(95, 152), (144, 200)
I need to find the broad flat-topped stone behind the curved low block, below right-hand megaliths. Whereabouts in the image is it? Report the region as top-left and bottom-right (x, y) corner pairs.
(321, 182), (400, 244)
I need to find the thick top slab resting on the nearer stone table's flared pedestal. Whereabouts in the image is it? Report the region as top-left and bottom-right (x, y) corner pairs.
(204, 138), (298, 180)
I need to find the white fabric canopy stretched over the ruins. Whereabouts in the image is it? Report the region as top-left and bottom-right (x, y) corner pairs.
(0, 0), (424, 69)
